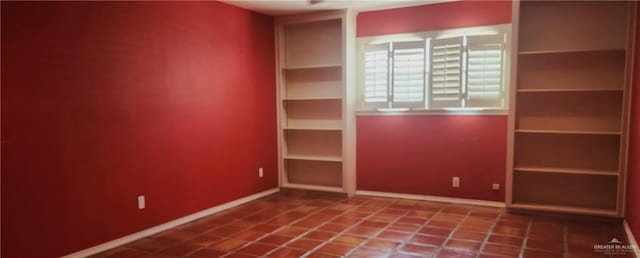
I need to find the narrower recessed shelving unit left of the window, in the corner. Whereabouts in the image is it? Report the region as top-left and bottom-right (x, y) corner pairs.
(277, 11), (355, 194)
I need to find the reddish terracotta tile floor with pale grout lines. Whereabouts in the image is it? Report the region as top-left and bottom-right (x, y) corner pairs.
(94, 191), (633, 258)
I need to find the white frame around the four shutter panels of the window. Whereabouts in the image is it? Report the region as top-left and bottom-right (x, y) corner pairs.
(356, 24), (512, 115)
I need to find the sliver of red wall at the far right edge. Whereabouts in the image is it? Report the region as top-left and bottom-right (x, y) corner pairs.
(626, 8), (640, 244)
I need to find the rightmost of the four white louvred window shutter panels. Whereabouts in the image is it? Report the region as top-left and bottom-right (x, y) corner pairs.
(466, 35), (504, 107)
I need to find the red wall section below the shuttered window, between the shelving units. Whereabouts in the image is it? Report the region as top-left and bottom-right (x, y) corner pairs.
(357, 115), (507, 201)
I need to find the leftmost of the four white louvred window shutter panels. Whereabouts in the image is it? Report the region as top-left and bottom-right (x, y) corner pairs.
(364, 44), (389, 102)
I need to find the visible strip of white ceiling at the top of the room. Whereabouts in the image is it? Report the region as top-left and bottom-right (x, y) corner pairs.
(221, 0), (451, 16)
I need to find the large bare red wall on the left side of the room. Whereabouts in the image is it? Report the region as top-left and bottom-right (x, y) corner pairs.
(1, 1), (277, 258)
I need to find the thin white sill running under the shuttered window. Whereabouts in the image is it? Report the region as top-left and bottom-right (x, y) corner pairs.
(356, 109), (509, 116)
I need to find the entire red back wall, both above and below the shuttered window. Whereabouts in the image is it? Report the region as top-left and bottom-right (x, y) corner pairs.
(357, 1), (511, 201)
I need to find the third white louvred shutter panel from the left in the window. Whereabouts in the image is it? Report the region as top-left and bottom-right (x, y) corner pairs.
(429, 37), (464, 108)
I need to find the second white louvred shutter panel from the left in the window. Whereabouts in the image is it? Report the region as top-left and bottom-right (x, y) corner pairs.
(392, 40), (425, 107)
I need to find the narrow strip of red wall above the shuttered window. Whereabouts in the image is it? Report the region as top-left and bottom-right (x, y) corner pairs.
(357, 1), (511, 37)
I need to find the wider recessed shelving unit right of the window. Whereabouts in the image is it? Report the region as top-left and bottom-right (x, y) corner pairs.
(507, 1), (636, 217)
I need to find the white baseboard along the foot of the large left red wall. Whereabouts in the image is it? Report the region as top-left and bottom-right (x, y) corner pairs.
(62, 188), (280, 258)
